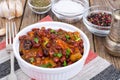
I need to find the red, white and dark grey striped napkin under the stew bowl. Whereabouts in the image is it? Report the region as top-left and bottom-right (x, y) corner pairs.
(0, 16), (120, 80)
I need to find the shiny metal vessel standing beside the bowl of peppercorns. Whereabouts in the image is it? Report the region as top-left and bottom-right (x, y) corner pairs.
(104, 9), (120, 56)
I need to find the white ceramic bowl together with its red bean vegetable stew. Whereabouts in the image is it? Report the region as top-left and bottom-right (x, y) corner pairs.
(13, 22), (90, 80)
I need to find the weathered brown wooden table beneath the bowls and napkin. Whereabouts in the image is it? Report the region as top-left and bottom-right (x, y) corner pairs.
(0, 0), (120, 69)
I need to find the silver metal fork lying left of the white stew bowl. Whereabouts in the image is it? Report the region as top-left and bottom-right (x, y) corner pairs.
(6, 21), (17, 80)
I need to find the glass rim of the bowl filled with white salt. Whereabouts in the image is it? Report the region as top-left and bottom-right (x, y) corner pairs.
(52, 0), (87, 18)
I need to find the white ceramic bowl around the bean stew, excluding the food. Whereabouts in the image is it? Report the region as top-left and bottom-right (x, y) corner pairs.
(13, 22), (90, 80)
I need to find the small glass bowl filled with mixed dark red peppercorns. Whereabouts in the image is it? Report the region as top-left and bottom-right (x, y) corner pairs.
(83, 6), (112, 36)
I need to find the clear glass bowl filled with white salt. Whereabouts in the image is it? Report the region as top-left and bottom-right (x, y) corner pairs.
(51, 0), (89, 23)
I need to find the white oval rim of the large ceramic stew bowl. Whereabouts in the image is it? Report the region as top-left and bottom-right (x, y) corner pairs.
(13, 21), (90, 73)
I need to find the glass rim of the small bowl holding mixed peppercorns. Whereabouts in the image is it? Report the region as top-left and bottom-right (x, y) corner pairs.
(83, 5), (113, 29)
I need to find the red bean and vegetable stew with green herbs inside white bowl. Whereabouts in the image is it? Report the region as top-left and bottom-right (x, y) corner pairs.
(19, 27), (84, 68)
